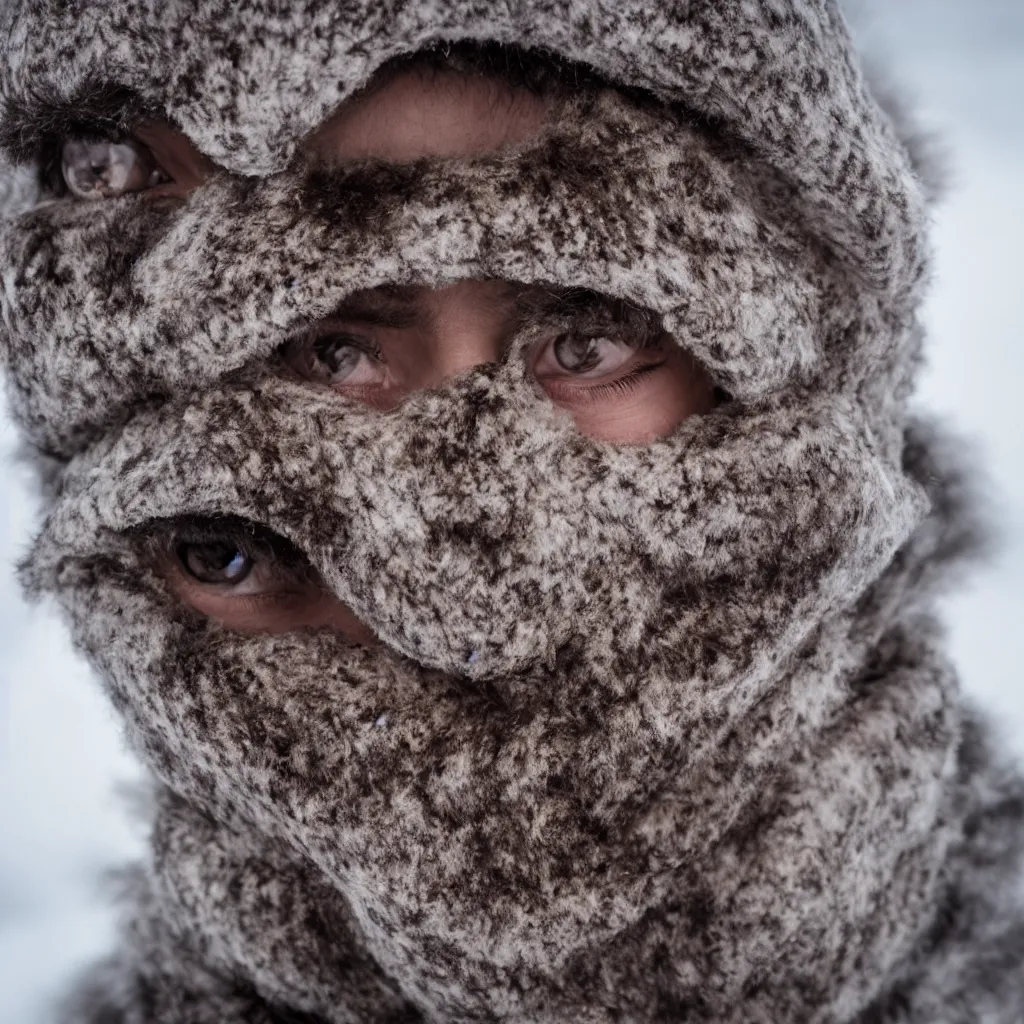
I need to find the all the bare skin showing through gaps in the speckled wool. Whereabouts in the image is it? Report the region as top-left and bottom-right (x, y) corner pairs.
(61, 61), (714, 643)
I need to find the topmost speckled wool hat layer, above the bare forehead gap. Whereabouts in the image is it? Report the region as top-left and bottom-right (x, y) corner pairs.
(0, 0), (921, 288)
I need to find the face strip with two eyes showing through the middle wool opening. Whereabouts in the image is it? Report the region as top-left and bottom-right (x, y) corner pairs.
(284, 281), (713, 444)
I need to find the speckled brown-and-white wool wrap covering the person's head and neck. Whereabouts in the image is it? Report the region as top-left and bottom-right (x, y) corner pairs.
(0, 0), (1024, 1024)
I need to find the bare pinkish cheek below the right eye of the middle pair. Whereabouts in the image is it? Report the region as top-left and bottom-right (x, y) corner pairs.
(568, 350), (715, 444)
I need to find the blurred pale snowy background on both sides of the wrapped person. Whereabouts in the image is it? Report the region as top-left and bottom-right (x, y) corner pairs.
(0, 0), (1024, 1024)
